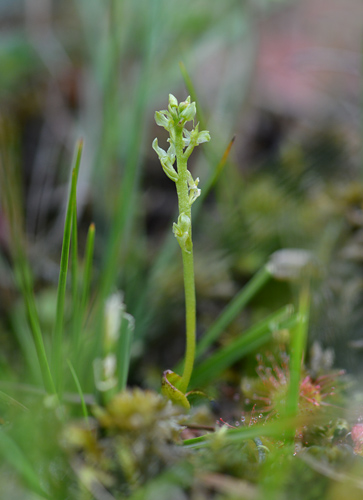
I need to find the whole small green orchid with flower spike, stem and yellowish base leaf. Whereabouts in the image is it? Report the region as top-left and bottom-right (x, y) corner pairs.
(152, 94), (210, 408)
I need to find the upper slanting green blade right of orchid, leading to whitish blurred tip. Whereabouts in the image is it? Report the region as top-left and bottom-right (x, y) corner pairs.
(196, 266), (271, 358)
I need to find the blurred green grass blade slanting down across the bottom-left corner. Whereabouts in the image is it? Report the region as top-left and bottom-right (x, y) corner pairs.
(0, 428), (49, 499)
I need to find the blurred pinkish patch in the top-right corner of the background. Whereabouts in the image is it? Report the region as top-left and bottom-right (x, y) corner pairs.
(252, 0), (363, 117)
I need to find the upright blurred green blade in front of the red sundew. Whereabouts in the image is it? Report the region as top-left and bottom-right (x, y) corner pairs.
(286, 281), (310, 424)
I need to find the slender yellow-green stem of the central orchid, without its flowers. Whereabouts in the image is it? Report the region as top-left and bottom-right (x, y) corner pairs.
(175, 126), (196, 393)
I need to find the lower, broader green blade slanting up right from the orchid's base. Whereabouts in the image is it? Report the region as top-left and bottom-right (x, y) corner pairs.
(190, 305), (296, 388)
